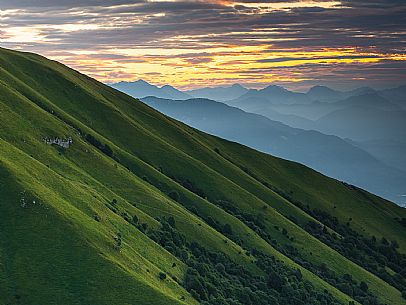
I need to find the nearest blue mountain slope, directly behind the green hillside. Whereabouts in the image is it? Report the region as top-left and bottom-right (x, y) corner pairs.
(142, 97), (406, 202)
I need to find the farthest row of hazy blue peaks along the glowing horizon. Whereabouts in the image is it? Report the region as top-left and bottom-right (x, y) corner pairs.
(109, 79), (406, 107)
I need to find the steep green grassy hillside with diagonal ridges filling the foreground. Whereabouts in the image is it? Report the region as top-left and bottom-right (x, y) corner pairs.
(0, 49), (406, 305)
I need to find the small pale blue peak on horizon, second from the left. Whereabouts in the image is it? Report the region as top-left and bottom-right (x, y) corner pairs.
(185, 84), (248, 102)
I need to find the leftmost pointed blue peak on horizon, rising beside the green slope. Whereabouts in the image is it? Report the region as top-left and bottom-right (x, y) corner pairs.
(110, 79), (191, 99)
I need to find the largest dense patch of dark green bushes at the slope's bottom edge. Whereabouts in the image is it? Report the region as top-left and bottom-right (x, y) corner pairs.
(147, 217), (340, 305)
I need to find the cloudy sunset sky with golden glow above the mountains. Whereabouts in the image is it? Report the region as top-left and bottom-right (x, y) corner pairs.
(0, 0), (406, 90)
